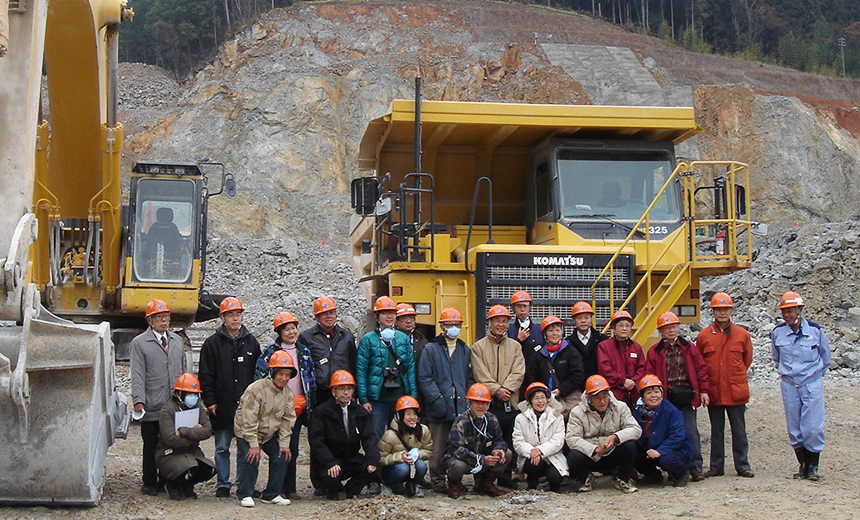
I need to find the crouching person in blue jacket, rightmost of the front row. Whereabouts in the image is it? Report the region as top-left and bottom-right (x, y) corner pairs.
(633, 374), (693, 487)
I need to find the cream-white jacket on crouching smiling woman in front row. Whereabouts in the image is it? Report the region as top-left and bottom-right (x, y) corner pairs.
(513, 399), (570, 477)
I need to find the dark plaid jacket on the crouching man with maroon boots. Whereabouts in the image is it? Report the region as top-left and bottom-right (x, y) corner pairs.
(442, 410), (508, 468)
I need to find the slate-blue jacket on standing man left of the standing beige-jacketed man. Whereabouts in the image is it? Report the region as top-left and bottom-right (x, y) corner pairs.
(418, 334), (475, 422)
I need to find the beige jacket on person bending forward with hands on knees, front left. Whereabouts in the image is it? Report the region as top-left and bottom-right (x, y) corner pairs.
(233, 378), (296, 448)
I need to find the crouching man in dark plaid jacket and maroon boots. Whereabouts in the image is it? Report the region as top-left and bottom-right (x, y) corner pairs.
(442, 383), (511, 498)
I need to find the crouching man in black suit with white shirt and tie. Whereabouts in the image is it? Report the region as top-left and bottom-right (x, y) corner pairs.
(308, 370), (379, 500)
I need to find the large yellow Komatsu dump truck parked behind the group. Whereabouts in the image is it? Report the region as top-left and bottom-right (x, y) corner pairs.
(350, 100), (757, 342)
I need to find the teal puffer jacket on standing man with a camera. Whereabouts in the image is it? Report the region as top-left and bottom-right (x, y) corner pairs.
(355, 330), (417, 404)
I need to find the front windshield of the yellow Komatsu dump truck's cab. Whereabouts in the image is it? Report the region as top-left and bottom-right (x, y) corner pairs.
(558, 150), (680, 222)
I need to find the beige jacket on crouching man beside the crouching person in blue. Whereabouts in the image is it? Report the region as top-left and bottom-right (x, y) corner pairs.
(565, 392), (642, 461)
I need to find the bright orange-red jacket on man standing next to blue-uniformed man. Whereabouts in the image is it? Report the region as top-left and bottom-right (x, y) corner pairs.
(696, 324), (752, 406)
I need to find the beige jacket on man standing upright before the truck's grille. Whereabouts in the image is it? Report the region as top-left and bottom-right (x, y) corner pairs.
(470, 335), (526, 406)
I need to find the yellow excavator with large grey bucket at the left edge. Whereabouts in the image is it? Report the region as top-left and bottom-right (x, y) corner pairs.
(0, 0), (235, 505)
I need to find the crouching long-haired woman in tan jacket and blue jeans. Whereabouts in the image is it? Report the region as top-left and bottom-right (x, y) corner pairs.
(379, 395), (433, 498)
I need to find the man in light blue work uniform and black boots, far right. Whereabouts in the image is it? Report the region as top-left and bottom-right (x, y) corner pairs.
(770, 291), (830, 480)
